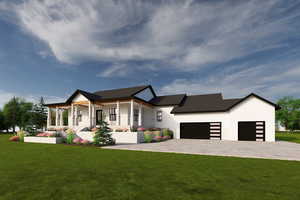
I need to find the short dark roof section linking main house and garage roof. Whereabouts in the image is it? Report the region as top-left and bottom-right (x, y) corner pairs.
(149, 94), (186, 106)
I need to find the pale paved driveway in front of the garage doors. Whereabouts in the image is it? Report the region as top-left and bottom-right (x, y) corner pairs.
(104, 139), (300, 161)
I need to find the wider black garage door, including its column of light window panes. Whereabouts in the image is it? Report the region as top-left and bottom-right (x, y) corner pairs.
(180, 122), (221, 139)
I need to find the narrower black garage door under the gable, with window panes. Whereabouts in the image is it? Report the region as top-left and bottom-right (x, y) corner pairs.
(238, 121), (265, 141)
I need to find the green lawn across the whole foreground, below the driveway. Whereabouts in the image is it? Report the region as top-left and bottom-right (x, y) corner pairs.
(0, 135), (300, 200)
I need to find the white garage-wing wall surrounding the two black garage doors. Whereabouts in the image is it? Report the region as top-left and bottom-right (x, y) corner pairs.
(175, 97), (275, 142)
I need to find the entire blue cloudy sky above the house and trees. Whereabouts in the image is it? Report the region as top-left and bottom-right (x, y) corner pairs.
(0, 0), (300, 107)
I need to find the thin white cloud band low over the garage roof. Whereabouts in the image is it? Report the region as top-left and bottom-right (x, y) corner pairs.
(160, 60), (300, 100)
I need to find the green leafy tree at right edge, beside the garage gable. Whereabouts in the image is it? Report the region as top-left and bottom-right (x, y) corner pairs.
(276, 97), (300, 131)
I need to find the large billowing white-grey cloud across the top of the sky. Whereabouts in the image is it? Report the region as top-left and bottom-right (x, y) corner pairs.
(1, 0), (300, 70)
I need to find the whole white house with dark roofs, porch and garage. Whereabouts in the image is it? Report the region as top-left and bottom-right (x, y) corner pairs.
(46, 85), (279, 142)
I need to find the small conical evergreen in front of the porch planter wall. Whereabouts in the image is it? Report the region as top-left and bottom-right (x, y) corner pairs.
(94, 121), (115, 146)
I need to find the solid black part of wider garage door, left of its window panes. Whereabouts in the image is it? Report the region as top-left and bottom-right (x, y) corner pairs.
(180, 123), (210, 139)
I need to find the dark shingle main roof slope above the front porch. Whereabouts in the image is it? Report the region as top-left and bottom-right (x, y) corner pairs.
(94, 85), (150, 100)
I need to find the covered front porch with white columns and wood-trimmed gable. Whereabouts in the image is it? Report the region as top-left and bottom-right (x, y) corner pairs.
(47, 96), (152, 132)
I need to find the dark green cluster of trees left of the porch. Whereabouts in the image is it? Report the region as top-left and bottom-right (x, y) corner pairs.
(0, 97), (47, 132)
